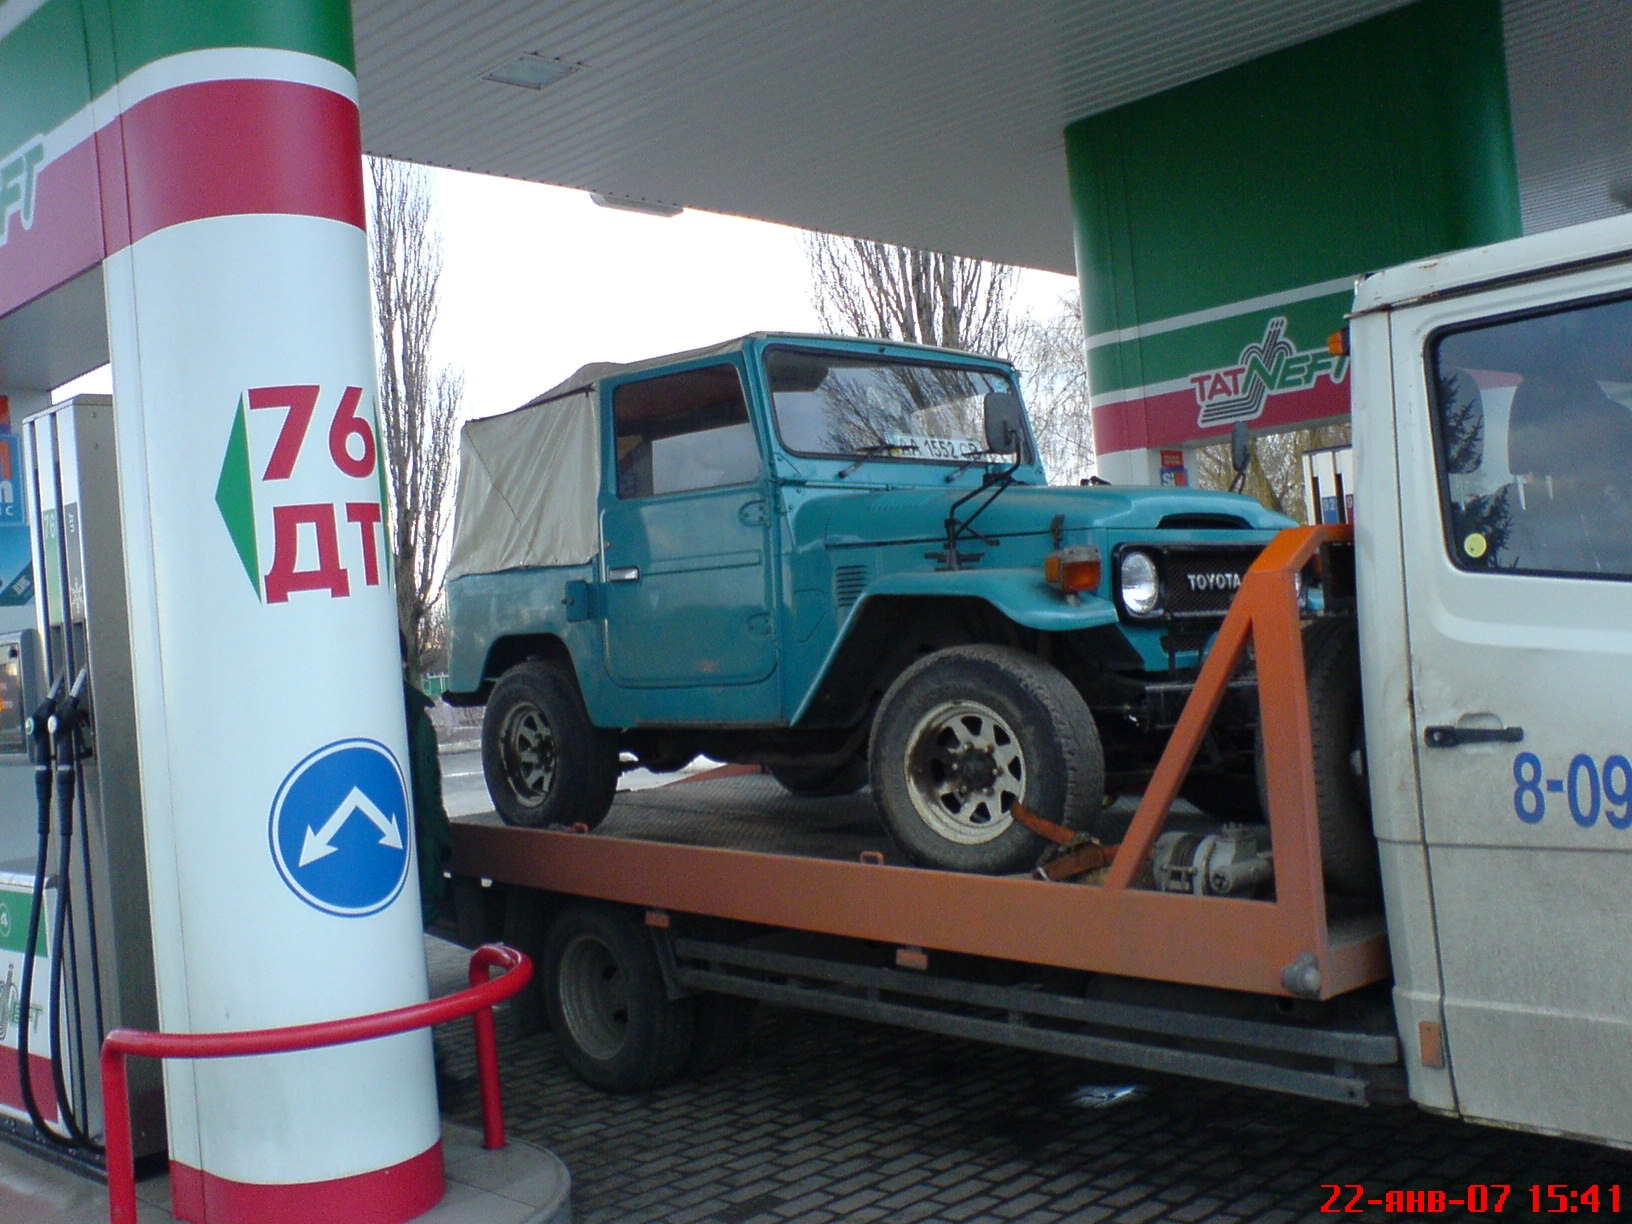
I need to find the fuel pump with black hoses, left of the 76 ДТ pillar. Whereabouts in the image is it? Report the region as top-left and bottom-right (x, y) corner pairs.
(0, 397), (165, 1155)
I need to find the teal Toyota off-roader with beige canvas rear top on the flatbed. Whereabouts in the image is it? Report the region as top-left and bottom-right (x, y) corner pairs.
(447, 335), (1289, 871)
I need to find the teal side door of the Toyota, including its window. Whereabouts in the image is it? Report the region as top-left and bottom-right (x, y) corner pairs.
(601, 361), (777, 695)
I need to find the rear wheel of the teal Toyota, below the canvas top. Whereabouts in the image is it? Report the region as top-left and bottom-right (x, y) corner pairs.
(481, 659), (619, 829)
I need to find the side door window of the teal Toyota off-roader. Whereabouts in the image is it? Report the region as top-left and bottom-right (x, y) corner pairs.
(612, 366), (759, 498)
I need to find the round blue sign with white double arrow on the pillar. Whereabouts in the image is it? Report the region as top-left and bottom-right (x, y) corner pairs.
(269, 739), (413, 917)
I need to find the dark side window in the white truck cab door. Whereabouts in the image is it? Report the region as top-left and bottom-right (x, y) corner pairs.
(1428, 299), (1632, 579)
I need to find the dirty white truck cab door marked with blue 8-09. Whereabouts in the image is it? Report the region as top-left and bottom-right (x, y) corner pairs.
(1383, 282), (1632, 1144)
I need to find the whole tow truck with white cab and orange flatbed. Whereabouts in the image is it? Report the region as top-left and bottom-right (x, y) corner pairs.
(452, 220), (1632, 1147)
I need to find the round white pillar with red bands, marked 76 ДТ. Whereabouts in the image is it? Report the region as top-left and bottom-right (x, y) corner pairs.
(98, 28), (442, 1224)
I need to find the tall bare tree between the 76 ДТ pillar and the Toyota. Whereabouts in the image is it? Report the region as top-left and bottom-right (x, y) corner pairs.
(369, 157), (465, 674)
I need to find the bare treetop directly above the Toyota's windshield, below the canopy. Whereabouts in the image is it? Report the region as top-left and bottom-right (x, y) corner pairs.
(805, 233), (1015, 356)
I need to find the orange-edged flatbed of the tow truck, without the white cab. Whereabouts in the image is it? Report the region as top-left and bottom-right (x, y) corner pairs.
(452, 529), (1404, 1103)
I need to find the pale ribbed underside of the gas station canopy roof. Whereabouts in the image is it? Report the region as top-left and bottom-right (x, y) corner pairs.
(354, 0), (1632, 273)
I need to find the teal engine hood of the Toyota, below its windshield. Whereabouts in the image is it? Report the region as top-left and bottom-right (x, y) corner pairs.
(798, 485), (1293, 547)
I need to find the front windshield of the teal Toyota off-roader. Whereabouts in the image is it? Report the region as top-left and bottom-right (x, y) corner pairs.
(765, 349), (1013, 463)
